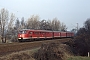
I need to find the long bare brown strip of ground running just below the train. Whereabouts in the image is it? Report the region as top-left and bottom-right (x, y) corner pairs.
(0, 38), (70, 57)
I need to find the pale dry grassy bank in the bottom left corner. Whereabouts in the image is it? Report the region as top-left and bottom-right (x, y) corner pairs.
(0, 48), (39, 60)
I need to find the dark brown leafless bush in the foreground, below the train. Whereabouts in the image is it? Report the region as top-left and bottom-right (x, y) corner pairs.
(34, 43), (73, 60)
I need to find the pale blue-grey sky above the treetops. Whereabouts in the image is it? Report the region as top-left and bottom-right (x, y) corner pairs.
(0, 0), (90, 30)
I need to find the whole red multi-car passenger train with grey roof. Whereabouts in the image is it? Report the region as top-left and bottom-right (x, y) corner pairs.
(18, 29), (74, 42)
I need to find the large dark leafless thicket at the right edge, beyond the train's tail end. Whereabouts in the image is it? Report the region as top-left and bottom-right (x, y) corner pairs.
(69, 19), (90, 56)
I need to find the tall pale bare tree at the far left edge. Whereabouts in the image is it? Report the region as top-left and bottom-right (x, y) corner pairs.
(0, 8), (9, 43)
